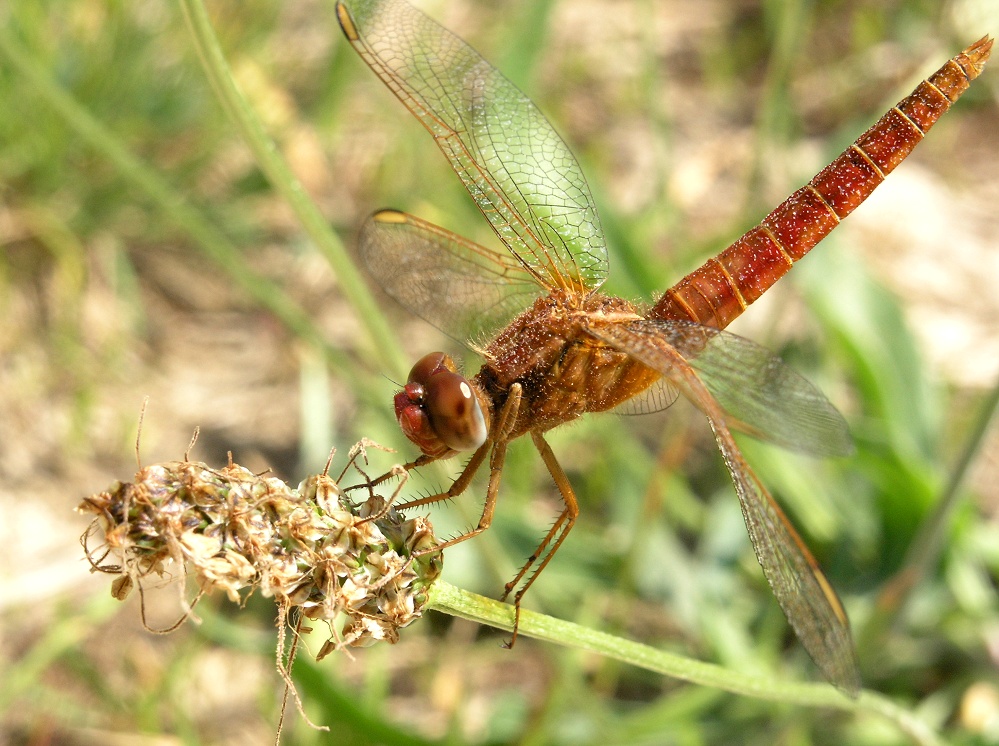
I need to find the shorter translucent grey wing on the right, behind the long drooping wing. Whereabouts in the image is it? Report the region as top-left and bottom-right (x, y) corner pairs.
(644, 321), (853, 456)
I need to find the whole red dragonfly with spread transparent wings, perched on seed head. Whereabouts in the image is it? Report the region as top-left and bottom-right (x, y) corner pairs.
(336, 0), (992, 695)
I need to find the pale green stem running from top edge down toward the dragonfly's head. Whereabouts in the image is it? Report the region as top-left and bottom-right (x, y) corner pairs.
(179, 0), (408, 374)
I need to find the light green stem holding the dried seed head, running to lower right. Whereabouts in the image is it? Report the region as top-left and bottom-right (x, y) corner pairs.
(428, 581), (942, 746)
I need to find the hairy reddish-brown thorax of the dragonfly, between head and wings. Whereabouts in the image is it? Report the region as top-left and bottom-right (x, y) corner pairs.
(473, 291), (659, 437)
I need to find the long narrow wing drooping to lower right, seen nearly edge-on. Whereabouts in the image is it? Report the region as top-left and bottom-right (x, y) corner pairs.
(589, 321), (861, 696)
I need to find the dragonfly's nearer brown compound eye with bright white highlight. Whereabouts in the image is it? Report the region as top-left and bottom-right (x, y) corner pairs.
(421, 366), (488, 451)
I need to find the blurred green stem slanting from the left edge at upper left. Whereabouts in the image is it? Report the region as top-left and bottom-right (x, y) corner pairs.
(0, 25), (346, 368)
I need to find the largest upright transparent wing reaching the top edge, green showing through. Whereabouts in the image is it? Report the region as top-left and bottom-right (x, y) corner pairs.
(337, 0), (607, 292)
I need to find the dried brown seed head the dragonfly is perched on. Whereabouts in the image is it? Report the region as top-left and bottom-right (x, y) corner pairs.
(84, 448), (442, 657)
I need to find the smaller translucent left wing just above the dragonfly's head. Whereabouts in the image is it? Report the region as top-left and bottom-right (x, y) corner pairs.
(359, 210), (544, 343)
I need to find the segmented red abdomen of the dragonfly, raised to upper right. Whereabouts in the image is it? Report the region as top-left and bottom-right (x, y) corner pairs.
(648, 37), (992, 329)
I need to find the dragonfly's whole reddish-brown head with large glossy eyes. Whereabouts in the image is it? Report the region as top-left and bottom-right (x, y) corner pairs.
(395, 352), (489, 458)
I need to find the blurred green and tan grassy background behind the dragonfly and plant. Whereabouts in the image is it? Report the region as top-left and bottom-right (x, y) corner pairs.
(0, 0), (999, 744)
